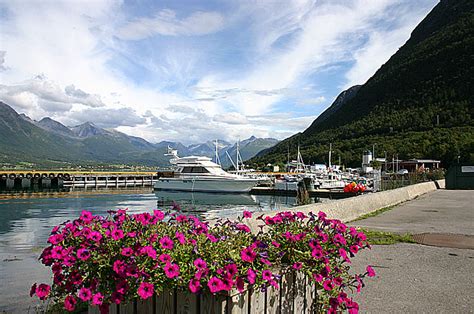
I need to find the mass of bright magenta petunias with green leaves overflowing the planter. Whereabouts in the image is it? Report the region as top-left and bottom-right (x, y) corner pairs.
(30, 210), (375, 312)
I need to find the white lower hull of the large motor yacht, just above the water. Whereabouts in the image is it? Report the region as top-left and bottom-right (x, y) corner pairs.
(155, 178), (258, 193)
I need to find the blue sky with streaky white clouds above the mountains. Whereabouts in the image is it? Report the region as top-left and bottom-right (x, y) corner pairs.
(0, 0), (438, 144)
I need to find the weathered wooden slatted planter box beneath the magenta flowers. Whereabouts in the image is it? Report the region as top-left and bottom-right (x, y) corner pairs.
(89, 272), (318, 314)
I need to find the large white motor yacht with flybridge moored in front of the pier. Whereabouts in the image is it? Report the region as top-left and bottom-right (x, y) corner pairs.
(155, 150), (259, 193)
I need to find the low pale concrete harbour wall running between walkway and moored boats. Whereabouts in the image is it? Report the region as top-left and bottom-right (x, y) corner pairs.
(248, 180), (444, 231)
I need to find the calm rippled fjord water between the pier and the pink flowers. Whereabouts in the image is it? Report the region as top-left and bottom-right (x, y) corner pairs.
(0, 188), (322, 313)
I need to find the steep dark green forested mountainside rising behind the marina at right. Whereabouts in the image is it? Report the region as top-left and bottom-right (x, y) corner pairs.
(251, 0), (474, 166)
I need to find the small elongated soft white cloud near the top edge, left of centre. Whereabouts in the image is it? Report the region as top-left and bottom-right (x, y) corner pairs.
(117, 9), (224, 40)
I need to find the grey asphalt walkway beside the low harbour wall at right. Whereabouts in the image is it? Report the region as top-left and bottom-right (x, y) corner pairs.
(351, 190), (474, 313)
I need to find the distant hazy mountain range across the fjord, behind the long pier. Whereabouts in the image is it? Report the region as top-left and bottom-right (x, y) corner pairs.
(0, 101), (278, 167)
